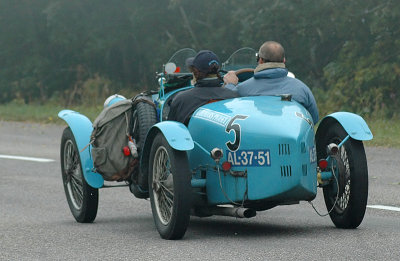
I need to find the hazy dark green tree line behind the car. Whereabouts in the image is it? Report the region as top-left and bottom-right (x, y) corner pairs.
(0, 0), (400, 118)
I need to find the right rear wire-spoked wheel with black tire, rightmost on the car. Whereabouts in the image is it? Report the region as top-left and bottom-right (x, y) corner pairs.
(317, 121), (368, 228)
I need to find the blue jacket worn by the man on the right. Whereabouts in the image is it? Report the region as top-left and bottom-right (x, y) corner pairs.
(225, 68), (319, 124)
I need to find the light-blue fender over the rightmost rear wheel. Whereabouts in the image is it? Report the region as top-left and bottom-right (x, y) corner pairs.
(316, 112), (373, 140)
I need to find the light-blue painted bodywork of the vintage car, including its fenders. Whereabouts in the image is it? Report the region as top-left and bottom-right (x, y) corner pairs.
(59, 47), (372, 209)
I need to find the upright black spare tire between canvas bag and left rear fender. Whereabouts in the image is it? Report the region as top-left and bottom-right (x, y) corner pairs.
(132, 101), (157, 152)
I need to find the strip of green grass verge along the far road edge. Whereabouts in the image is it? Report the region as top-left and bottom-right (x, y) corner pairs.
(0, 103), (400, 148)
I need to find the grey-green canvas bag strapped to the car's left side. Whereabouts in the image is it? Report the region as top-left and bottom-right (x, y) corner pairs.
(90, 99), (134, 181)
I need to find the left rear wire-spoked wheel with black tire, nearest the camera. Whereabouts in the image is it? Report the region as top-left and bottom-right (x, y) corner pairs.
(149, 133), (191, 239)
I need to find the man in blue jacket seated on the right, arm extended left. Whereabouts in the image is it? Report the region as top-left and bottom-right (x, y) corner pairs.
(224, 41), (319, 124)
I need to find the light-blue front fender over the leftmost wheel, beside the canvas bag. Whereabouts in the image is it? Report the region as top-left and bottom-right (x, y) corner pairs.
(58, 110), (104, 188)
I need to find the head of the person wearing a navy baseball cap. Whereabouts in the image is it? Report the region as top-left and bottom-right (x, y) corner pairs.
(186, 50), (220, 80)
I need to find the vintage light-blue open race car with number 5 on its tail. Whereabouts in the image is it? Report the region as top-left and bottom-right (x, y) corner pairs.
(59, 48), (372, 239)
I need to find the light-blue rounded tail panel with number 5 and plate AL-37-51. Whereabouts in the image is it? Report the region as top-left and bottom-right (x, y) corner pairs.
(189, 96), (317, 204)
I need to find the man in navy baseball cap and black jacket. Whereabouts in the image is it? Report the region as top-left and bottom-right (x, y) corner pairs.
(168, 50), (239, 125)
